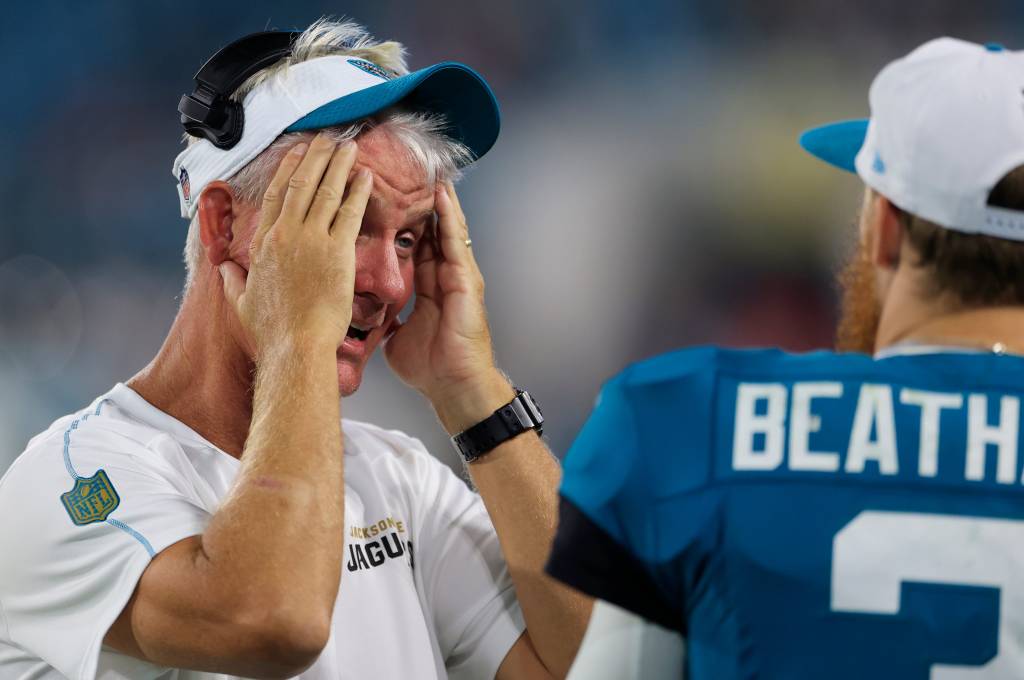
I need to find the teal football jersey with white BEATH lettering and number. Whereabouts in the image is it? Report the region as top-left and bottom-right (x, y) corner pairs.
(548, 348), (1024, 680)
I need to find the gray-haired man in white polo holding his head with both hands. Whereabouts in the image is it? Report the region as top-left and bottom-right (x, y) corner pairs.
(0, 22), (589, 680)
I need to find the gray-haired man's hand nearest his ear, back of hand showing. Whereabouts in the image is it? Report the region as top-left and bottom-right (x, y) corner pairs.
(220, 134), (373, 359)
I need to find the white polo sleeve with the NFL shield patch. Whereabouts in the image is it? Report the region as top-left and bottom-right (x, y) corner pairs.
(0, 418), (209, 680)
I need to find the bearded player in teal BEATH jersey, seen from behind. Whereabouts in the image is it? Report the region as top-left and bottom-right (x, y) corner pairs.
(548, 38), (1024, 680)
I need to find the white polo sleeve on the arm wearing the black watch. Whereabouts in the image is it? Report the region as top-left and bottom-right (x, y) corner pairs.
(414, 442), (525, 680)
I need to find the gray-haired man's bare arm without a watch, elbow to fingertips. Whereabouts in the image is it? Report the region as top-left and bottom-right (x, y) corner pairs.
(104, 130), (373, 678)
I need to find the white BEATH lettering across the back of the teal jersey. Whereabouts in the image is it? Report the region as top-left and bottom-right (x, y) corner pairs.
(731, 381), (1024, 484)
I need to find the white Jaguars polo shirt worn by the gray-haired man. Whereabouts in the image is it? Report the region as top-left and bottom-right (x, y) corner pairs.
(0, 384), (524, 680)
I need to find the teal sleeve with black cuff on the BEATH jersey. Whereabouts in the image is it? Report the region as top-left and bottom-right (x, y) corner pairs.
(547, 375), (682, 630)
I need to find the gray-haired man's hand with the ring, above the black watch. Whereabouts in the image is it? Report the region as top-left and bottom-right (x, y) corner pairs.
(384, 182), (505, 405)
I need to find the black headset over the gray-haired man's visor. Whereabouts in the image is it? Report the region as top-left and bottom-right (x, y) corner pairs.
(178, 31), (299, 148)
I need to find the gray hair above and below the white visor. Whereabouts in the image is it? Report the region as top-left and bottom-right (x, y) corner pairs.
(184, 18), (473, 293)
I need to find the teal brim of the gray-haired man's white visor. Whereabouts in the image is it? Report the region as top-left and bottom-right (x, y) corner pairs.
(286, 61), (501, 165)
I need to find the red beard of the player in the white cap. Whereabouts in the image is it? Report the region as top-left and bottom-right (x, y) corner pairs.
(836, 245), (882, 354)
